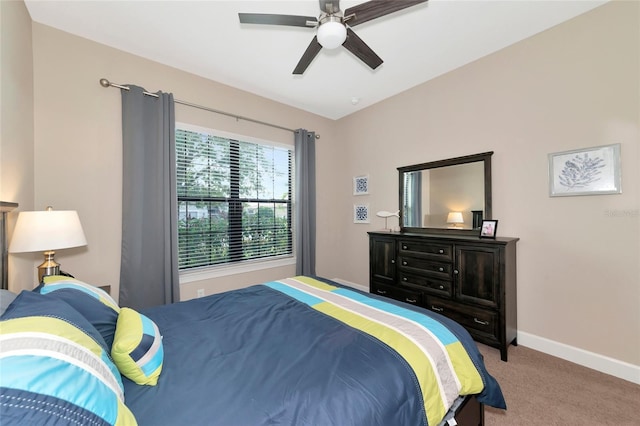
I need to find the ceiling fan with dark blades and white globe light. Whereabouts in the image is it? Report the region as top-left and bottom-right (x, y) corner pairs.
(238, 0), (427, 74)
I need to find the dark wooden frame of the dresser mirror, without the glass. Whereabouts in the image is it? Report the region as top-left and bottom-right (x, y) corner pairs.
(398, 151), (493, 235)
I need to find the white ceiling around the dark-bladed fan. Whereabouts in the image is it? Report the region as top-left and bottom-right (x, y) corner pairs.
(25, 0), (607, 119)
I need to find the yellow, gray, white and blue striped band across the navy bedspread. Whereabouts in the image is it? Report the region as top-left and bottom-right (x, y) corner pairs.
(264, 276), (484, 425)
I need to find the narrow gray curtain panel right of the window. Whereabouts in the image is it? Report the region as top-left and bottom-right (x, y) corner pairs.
(294, 129), (316, 275)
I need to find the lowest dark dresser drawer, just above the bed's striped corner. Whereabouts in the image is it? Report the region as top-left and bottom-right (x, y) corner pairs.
(426, 297), (499, 342)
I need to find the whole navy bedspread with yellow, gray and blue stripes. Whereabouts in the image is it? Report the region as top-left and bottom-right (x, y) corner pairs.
(123, 277), (504, 426)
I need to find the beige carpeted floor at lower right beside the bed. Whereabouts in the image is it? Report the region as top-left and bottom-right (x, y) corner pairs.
(478, 344), (640, 426)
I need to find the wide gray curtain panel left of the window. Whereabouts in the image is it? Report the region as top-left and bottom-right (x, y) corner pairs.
(119, 85), (180, 309)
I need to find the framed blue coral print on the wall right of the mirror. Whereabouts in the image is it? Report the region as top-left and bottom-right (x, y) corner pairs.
(549, 144), (622, 197)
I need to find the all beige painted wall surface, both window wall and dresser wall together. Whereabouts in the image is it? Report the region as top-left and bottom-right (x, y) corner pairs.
(2, 2), (640, 371)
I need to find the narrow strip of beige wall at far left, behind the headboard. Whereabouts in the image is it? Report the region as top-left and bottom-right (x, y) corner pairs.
(0, 1), (34, 284)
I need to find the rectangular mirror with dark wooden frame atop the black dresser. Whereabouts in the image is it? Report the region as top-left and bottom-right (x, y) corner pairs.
(398, 152), (493, 234)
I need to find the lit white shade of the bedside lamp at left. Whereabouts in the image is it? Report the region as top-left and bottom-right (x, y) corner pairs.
(9, 210), (87, 253)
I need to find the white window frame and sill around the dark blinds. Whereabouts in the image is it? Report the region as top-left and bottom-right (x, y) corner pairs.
(175, 122), (296, 283)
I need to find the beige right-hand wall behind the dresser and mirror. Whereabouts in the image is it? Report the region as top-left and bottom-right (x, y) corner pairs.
(333, 2), (640, 366)
